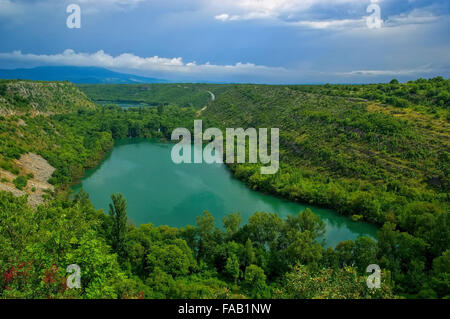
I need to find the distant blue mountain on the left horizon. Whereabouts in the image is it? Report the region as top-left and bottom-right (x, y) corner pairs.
(0, 66), (169, 84)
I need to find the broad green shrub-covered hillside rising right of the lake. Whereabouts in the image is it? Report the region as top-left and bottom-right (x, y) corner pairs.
(201, 79), (450, 249)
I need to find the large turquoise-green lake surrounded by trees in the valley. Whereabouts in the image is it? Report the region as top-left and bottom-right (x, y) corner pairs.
(74, 139), (376, 246)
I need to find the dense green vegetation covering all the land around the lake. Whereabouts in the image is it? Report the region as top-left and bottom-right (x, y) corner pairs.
(0, 78), (450, 298)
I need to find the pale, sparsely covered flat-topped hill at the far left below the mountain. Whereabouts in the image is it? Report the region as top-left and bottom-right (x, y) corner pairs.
(0, 80), (96, 114)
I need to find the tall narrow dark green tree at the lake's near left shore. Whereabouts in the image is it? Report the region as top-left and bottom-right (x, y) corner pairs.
(109, 194), (127, 257)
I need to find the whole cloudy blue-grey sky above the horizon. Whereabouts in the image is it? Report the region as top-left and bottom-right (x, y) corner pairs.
(0, 0), (450, 84)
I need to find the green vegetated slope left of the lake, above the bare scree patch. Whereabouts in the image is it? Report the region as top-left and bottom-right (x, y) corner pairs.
(0, 81), (194, 188)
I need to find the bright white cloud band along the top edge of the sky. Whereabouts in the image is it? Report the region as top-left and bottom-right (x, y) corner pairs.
(0, 0), (439, 29)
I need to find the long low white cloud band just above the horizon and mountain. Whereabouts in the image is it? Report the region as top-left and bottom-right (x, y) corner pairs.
(0, 49), (442, 83)
